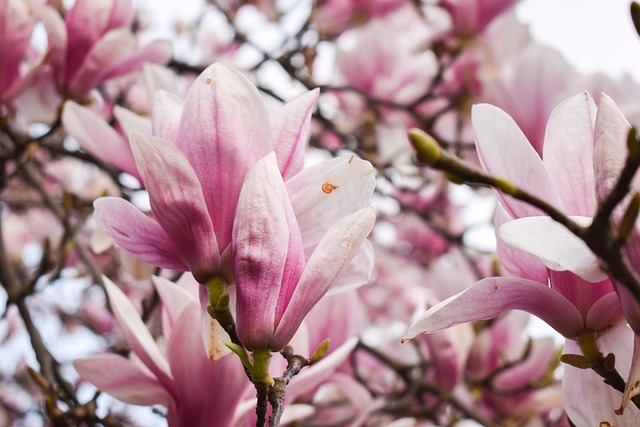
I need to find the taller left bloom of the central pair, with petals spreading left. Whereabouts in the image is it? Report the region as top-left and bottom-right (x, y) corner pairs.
(95, 64), (318, 283)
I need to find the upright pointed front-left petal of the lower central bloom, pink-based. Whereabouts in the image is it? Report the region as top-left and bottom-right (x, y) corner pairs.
(233, 152), (304, 350)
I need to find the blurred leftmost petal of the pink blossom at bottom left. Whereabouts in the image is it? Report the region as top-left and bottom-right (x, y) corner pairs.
(73, 353), (172, 406)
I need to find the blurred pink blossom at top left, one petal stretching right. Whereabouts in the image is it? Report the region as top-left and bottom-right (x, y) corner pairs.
(42, 0), (171, 99)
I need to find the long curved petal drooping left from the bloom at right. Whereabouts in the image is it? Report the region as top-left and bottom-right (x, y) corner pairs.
(402, 277), (584, 341)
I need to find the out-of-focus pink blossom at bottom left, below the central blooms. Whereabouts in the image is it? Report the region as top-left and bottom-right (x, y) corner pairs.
(74, 278), (248, 427)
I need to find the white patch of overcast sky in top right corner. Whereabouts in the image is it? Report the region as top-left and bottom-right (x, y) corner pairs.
(517, 0), (640, 82)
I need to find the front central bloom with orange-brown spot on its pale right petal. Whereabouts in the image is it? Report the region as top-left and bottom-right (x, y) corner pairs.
(233, 153), (375, 351)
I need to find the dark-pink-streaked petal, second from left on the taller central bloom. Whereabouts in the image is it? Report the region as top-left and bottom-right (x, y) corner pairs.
(131, 132), (220, 283)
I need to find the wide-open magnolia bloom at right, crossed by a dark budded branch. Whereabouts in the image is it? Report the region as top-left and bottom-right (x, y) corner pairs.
(405, 92), (640, 426)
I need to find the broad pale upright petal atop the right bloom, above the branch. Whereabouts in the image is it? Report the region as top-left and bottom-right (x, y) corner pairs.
(542, 92), (597, 216)
